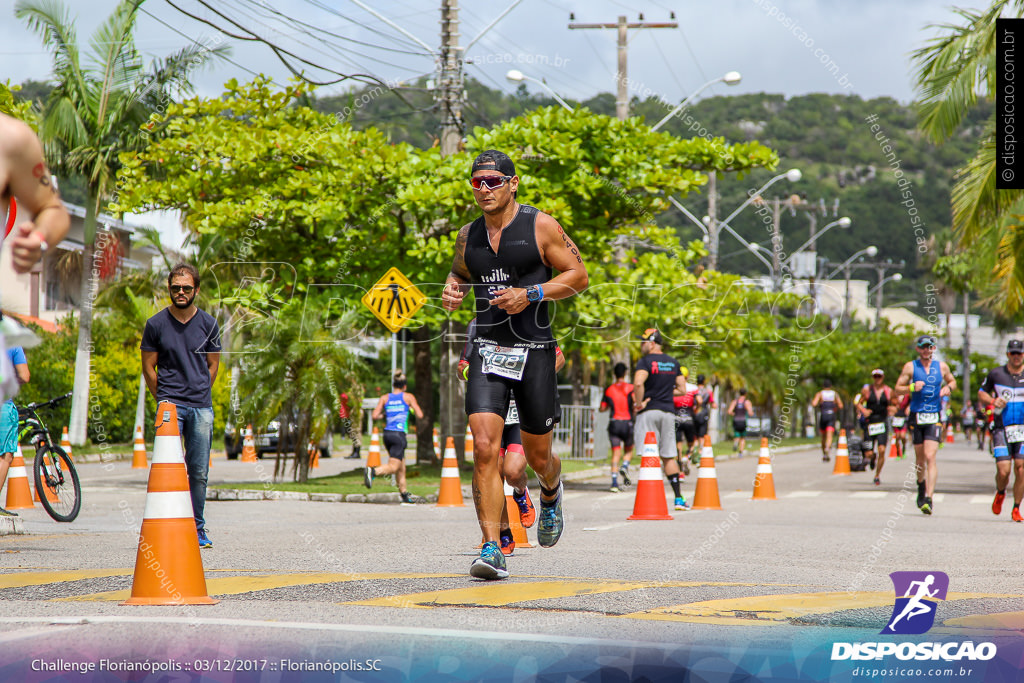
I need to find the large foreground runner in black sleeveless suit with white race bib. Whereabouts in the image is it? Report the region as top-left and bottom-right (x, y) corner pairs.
(441, 150), (588, 580)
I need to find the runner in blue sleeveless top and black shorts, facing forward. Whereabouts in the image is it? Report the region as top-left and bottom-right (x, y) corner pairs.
(896, 335), (956, 515)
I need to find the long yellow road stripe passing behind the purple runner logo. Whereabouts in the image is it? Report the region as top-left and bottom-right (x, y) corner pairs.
(622, 591), (1020, 626)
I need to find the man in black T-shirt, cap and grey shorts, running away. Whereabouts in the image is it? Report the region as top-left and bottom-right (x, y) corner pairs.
(633, 328), (690, 510)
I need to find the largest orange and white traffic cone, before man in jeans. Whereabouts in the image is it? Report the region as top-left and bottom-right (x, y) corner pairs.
(122, 401), (219, 605)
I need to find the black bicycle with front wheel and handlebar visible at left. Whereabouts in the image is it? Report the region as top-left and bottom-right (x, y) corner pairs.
(17, 392), (82, 522)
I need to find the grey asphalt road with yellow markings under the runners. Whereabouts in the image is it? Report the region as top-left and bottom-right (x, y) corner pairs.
(0, 442), (1024, 681)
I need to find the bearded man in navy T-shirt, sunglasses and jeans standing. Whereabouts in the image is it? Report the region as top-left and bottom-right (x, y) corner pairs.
(140, 263), (220, 548)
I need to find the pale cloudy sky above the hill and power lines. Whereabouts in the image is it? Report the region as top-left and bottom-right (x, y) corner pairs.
(0, 0), (966, 107)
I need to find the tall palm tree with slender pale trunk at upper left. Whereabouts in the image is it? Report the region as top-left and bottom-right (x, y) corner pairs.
(14, 0), (224, 444)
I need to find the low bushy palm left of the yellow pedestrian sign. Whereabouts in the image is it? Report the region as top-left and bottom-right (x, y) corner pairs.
(239, 299), (366, 481)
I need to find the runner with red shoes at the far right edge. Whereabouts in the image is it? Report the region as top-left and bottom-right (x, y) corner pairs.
(978, 339), (1024, 522)
